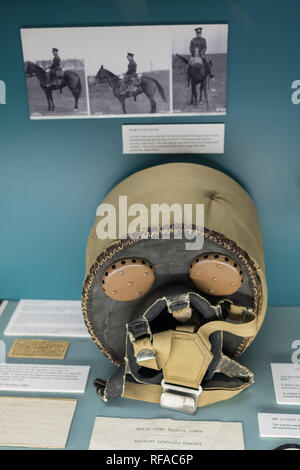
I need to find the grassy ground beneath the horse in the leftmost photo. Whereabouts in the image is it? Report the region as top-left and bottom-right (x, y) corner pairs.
(26, 69), (87, 117)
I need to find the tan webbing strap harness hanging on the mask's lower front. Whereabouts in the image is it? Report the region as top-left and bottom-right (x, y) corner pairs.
(95, 309), (257, 407)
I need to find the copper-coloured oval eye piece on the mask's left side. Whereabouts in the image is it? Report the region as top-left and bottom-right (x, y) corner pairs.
(101, 258), (155, 302)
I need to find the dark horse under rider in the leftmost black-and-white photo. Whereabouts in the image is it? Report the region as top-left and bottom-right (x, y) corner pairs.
(25, 62), (82, 111)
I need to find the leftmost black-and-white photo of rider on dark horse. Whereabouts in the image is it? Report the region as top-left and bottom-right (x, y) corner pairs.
(21, 28), (88, 118)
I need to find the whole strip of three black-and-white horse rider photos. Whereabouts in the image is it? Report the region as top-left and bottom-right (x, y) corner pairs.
(21, 24), (228, 119)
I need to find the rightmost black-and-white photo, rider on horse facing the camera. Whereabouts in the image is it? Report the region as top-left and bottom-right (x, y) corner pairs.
(172, 24), (228, 114)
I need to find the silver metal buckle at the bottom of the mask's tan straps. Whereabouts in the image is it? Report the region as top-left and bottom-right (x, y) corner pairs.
(160, 379), (202, 414)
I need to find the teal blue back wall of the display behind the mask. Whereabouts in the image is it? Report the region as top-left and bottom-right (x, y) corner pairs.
(0, 0), (300, 305)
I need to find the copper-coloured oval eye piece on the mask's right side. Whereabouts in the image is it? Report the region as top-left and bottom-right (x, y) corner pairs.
(189, 253), (243, 296)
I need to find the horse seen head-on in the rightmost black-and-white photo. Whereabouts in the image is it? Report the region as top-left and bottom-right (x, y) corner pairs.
(176, 54), (209, 110)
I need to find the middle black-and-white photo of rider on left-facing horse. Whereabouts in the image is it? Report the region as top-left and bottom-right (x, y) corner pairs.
(84, 26), (171, 116)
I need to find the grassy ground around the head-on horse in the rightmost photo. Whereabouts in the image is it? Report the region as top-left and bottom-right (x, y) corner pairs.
(173, 54), (227, 113)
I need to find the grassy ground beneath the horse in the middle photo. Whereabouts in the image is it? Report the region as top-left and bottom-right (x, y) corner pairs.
(89, 70), (170, 115)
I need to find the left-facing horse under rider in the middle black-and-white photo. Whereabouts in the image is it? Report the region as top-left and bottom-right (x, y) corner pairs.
(96, 65), (167, 114)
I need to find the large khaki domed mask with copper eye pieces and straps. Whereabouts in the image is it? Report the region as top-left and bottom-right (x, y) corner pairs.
(82, 163), (267, 413)
